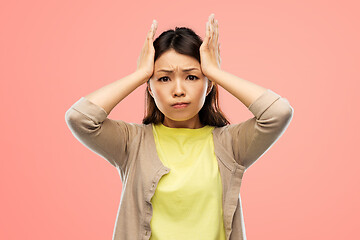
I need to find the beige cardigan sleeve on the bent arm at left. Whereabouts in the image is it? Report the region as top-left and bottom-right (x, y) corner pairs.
(65, 97), (140, 170)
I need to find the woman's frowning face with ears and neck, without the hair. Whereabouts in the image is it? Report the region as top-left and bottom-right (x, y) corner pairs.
(148, 49), (212, 128)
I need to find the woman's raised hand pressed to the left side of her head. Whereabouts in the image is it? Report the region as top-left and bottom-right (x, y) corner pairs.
(136, 19), (158, 80)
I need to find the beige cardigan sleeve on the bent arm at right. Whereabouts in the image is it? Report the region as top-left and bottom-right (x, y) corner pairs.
(228, 89), (294, 170)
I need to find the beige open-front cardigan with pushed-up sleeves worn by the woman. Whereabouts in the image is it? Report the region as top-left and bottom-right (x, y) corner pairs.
(65, 89), (294, 240)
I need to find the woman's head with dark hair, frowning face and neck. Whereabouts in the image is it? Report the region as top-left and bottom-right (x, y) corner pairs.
(143, 27), (229, 127)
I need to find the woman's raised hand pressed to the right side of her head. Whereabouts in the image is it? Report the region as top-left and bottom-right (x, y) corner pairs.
(200, 13), (221, 76)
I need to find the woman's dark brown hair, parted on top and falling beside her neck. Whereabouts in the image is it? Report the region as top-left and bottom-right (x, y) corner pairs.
(143, 27), (230, 127)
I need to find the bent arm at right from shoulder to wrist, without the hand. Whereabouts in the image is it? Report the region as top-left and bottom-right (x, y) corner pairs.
(209, 70), (294, 169)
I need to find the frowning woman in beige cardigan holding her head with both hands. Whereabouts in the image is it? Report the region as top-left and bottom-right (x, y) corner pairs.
(65, 14), (293, 240)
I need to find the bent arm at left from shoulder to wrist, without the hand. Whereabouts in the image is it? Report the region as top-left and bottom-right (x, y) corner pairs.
(65, 71), (146, 171)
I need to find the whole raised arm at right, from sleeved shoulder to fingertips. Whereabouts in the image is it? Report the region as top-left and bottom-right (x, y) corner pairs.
(200, 14), (294, 169)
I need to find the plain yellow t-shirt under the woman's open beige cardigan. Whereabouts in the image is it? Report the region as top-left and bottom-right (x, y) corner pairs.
(150, 124), (225, 240)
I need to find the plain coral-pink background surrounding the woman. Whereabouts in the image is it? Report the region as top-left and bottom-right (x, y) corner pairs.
(0, 0), (360, 240)
